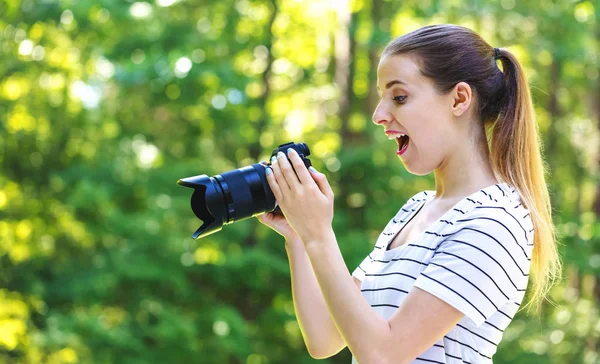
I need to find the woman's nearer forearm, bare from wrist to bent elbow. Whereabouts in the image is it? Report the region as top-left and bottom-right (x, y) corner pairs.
(306, 231), (390, 363)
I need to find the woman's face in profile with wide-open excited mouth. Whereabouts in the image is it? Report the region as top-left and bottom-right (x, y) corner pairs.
(373, 55), (460, 175)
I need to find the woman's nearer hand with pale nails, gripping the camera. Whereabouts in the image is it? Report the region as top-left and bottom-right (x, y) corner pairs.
(267, 148), (333, 245)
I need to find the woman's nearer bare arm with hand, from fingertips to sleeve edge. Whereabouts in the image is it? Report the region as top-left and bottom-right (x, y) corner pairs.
(267, 149), (490, 364)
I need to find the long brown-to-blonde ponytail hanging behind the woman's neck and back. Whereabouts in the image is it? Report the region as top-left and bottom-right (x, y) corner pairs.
(490, 49), (561, 310)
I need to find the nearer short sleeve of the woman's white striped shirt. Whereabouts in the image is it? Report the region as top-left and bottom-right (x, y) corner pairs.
(415, 210), (532, 326)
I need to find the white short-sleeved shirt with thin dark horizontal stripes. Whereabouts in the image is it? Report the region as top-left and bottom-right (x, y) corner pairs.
(352, 183), (534, 364)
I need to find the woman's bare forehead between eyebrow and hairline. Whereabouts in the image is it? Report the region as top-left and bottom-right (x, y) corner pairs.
(377, 55), (425, 90)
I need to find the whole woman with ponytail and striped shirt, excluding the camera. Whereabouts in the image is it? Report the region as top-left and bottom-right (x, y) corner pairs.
(259, 25), (560, 364)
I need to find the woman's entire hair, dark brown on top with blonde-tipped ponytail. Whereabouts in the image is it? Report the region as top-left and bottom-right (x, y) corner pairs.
(382, 24), (561, 310)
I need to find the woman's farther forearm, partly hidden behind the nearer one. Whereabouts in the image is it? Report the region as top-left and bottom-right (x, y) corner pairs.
(286, 236), (345, 358)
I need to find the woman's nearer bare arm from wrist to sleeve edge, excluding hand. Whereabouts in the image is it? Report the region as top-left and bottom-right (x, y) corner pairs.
(306, 232), (464, 364)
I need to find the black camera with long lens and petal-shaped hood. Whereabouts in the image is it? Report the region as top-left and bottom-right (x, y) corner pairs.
(177, 142), (311, 239)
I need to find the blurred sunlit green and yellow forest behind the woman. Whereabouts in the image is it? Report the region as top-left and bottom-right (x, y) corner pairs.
(0, 0), (600, 364)
